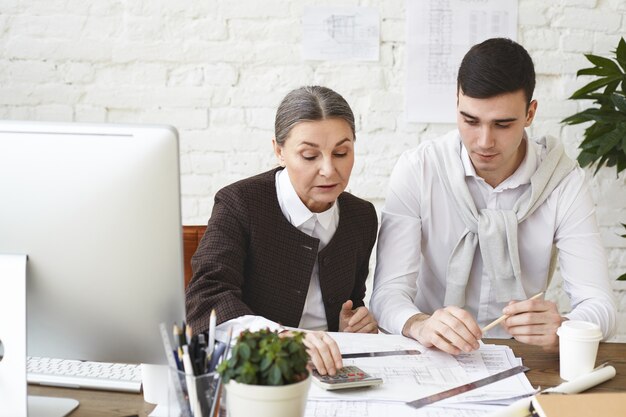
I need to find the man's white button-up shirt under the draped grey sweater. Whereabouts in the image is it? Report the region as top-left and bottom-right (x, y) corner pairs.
(370, 129), (616, 338)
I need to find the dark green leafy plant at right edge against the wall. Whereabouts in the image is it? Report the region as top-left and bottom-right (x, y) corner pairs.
(562, 38), (626, 281)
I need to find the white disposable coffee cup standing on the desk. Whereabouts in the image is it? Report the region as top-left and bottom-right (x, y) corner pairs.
(556, 320), (602, 381)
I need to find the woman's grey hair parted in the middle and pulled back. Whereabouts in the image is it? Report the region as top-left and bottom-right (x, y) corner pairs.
(274, 86), (356, 146)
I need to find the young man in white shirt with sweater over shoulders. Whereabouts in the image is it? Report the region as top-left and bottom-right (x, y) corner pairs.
(370, 38), (616, 354)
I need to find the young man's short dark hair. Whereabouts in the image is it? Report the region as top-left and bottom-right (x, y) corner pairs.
(457, 38), (535, 104)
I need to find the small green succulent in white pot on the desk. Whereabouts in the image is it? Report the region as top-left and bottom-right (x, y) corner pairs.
(217, 329), (311, 417)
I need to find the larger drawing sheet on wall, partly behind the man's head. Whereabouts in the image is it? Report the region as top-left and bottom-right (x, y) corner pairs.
(406, 0), (517, 123)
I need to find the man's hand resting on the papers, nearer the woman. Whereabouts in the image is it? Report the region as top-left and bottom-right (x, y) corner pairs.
(402, 306), (482, 355)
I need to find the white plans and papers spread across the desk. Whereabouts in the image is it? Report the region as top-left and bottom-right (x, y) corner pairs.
(305, 333), (536, 417)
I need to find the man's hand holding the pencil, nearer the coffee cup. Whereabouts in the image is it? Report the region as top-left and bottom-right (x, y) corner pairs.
(502, 299), (566, 352)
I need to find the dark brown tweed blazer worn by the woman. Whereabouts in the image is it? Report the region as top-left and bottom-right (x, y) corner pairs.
(185, 168), (378, 332)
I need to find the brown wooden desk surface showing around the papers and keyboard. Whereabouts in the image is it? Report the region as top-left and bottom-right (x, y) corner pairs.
(28, 339), (626, 417)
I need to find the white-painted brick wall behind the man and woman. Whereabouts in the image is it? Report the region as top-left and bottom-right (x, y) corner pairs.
(0, 0), (626, 341)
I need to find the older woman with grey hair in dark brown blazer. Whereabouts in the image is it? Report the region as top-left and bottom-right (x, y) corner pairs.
(186, 86), (378, 375)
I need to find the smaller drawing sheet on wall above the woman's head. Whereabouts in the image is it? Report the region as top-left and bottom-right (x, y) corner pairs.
(302, 6), (380, 61)
